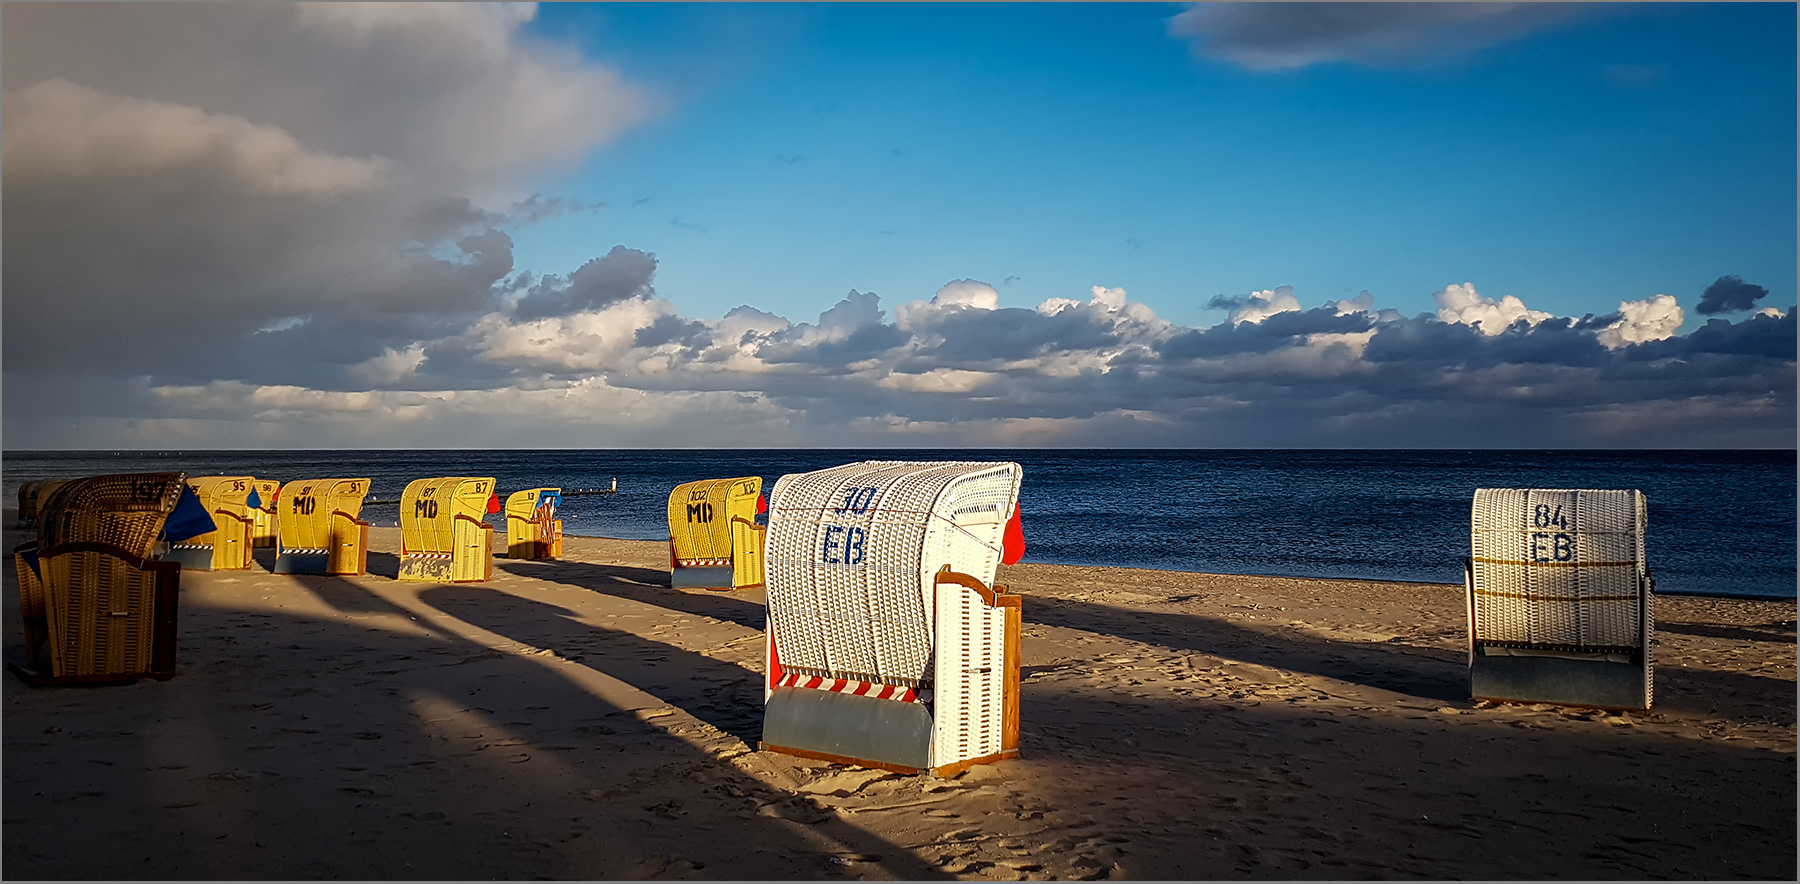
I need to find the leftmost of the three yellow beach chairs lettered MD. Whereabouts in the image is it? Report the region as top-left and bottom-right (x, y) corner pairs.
(275, 479), (369, 574)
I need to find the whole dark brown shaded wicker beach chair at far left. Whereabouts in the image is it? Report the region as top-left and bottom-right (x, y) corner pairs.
(9, 472), (201, 684)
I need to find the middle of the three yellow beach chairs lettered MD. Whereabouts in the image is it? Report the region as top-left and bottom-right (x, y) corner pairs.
(400, 475), (500, 583)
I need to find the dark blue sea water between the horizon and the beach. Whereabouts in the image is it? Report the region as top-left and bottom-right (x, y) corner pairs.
(0, 448), (1796, 598)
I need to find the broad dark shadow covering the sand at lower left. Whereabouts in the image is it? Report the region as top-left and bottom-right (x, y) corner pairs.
(4, 573), (943, 880)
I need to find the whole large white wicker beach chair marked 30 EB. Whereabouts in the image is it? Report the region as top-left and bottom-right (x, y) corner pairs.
(761, 461), (1024, 776)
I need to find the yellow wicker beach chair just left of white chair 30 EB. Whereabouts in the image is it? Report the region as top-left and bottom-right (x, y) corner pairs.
(670, 475), (765, 589)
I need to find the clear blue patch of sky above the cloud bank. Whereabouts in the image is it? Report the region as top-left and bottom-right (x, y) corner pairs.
(515, 4), (1795, 328)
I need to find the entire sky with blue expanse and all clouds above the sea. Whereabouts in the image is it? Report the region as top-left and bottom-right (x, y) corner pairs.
(0, 2), (1796, 450)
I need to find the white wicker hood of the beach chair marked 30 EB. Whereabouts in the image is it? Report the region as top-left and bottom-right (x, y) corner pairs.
(763, 461), (1021, 686)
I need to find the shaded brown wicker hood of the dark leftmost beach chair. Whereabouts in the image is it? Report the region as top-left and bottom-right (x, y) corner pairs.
(38, 472), (187, 558)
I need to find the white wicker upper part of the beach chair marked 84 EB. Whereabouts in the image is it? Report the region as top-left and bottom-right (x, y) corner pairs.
(1471, 488), (1647, 650)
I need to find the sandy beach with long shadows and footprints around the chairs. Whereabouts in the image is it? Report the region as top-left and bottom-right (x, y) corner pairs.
(4, 513), (1796, 880)
